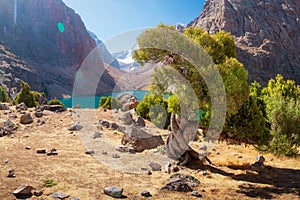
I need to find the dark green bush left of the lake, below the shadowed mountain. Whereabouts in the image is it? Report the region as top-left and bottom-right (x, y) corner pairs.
(15, 81), (41, 107)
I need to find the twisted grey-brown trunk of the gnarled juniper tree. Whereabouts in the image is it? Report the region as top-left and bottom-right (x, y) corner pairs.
(166, 113), (212, 165)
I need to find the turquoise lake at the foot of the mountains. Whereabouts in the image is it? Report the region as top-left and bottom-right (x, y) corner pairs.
(59, 90), (149, 108)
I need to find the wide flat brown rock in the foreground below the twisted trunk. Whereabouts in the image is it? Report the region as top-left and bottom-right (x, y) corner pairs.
(161, 174), (200, 192)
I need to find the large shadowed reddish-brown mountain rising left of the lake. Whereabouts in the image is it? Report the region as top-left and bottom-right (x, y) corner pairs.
(0, 0), (115, 98)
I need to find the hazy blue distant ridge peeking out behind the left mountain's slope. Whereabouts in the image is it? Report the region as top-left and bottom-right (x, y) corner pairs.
(88, 31), (120, 68)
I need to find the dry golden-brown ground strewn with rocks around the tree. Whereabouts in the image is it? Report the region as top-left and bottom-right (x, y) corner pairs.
(0, 106), (300, 200)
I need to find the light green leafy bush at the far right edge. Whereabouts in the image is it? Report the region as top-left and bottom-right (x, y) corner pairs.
(262, 75), (300, 156)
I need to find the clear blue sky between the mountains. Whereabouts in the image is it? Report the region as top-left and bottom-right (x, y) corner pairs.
(63, 0), (204, 41)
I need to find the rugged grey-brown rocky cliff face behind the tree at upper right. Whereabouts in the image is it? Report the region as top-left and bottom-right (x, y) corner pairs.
(189, 0), (300, 85)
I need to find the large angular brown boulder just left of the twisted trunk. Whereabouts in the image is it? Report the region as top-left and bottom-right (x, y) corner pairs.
(121, 125), (164, 152)
